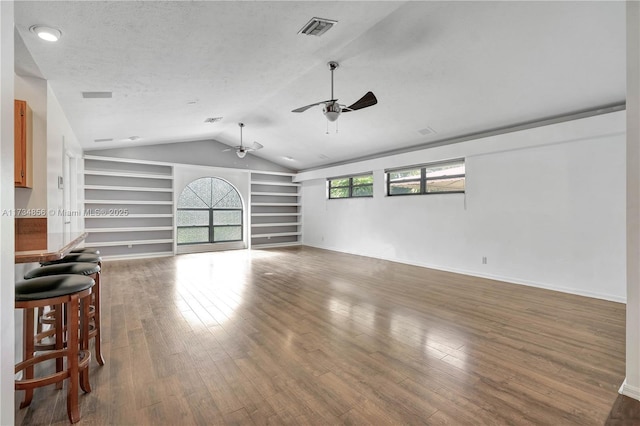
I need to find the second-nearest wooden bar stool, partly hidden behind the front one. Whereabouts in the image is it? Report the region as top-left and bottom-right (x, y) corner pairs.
(24, 262), (104, 365)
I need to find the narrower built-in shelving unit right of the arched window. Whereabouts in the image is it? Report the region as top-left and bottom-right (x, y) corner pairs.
(251, 172), (302, 248)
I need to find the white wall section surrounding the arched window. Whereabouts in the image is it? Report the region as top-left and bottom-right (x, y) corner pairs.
(173, 164), (250, 252)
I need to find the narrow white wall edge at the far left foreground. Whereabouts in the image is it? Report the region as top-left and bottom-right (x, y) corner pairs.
(0, 1), (15, 425)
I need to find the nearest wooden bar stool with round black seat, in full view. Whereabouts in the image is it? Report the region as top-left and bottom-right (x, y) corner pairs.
(15, 275), (94, 423)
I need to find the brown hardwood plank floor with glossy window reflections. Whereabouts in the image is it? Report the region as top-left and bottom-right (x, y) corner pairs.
(16, 247), (625, 425)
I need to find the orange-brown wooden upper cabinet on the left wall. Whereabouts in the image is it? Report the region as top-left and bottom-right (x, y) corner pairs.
(13, 100), (33, 188)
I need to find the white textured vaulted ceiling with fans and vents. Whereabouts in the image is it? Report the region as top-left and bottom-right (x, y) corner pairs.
(15, 1), (625, 170)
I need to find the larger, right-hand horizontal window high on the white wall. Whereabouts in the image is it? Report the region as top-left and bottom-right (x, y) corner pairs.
(386, 159), (465, 195)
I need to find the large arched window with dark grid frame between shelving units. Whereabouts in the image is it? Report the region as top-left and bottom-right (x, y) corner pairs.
(176, 177), (243, 245)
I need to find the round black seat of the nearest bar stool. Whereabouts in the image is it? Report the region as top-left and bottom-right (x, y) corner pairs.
(15, 274), (95, 302)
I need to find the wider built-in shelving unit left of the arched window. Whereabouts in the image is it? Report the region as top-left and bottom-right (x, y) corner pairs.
(84, 155), (174, 258)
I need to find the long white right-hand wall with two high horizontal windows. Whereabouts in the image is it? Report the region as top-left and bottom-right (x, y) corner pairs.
(296, 111), (626, 301)
